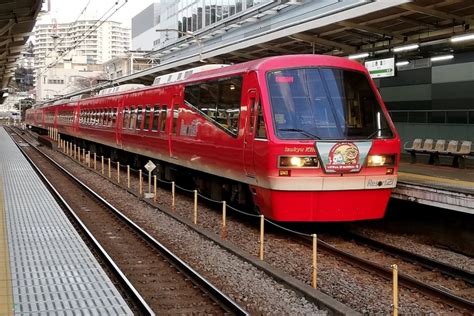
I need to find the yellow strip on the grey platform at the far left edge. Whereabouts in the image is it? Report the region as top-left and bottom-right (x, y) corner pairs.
(0, 178), (13, 316)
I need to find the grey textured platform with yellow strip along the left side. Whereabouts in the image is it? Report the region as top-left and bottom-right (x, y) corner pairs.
(0, 127), (133, 315)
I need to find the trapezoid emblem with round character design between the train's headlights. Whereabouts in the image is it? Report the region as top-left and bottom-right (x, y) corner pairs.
(315, 142), (372, 173)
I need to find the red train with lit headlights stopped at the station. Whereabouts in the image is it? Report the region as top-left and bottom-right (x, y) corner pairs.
(26, 55), (400, 221)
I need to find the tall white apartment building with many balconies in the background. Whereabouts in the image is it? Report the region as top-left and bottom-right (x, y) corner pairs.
(34, 20), (130, 72)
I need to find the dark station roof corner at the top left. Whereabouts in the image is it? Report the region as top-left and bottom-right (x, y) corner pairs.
(0, 0), (43, 90)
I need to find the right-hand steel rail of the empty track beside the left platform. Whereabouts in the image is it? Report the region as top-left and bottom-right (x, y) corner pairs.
(8, 128), (248, 315)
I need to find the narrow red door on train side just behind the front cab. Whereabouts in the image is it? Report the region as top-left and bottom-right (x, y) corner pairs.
(244, 89), (258, 177)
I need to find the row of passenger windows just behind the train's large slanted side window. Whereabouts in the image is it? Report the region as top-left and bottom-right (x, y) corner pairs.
(122, 104), (167, 132)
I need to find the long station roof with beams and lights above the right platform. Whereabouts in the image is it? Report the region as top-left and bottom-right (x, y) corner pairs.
(61, 0), (474, 97)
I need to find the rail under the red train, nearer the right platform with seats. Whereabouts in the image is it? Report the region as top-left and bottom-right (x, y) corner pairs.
(343, 233), (474, 285)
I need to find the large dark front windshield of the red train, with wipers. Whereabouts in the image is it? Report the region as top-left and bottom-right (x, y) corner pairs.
(267, 68), (393, 140)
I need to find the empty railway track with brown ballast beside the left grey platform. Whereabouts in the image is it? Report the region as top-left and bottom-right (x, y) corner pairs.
(9, 128), (247, 315)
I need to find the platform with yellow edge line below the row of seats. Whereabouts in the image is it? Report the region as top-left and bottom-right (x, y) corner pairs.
(392, 161), (474, 214)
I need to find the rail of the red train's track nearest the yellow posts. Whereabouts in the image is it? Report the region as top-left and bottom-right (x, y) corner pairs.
(300, 236), (474, 312)
